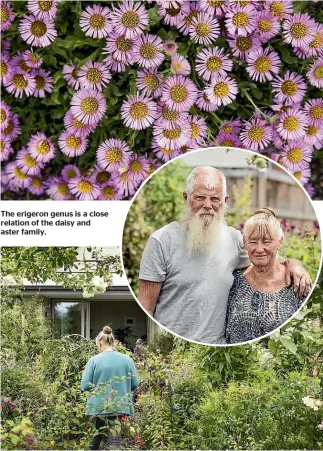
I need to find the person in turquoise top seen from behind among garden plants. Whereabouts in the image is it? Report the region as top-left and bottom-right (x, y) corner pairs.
(81, 326), (139, 449)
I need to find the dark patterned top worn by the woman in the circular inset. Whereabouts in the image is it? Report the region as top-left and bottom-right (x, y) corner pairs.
(226, 270), (305, 343)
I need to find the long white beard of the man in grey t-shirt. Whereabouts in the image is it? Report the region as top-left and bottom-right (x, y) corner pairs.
(182, 207), (226, 254)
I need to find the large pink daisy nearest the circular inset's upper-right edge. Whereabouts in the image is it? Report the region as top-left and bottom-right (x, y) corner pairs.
(280, 140), (313, 172)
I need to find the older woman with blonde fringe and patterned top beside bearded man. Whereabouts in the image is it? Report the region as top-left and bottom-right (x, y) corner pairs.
(226, 208), (305, 343)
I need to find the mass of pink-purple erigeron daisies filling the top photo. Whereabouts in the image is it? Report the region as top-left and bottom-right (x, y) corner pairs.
(1, 0), (323, 200)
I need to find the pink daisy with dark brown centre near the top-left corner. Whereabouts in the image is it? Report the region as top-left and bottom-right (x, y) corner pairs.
(19, 15), (57, 47)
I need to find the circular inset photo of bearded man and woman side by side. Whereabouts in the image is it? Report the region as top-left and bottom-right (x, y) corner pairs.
(122, 148), (321, 345)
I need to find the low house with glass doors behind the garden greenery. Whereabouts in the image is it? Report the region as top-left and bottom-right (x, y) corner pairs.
(24, 248), (160, 348)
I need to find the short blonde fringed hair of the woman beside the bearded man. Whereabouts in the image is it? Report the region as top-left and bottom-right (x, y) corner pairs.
(243, 208), (284, 240)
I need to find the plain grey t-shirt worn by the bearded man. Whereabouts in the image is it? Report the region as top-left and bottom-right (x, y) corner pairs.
(139, 221), (249, 344)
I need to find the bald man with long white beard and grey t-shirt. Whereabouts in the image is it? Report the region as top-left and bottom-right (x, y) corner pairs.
(138, 166), (311, 344)
